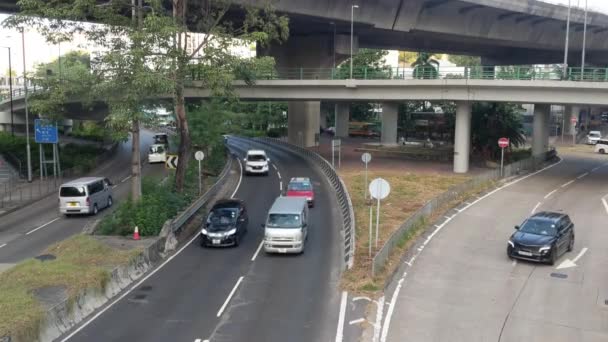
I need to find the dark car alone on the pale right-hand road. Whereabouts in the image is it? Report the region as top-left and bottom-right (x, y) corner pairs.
(507, 211), (574, 265)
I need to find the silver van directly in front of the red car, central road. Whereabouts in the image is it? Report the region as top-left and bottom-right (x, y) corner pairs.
(262, 197), (308, 253)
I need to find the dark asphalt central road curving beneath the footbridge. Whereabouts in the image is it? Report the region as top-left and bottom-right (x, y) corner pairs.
(62, 139), (342, 342)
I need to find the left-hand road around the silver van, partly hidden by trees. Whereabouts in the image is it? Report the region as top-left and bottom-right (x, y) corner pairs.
(0, 130), (165, 270)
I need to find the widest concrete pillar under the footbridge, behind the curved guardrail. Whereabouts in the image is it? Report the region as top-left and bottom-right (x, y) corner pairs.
(287, 101), (321, 147)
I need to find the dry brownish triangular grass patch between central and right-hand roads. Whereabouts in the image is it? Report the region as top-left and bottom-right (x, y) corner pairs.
(340, 170), (469, 292)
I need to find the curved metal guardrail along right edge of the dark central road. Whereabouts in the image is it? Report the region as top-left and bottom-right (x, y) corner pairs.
(248, 137), (356, 269)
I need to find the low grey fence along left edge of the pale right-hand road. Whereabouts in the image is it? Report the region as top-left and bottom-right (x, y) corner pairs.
(372, 150), (557, 277)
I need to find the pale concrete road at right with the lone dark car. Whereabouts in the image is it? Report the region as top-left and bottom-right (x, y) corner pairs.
(381, 154), (608, 342)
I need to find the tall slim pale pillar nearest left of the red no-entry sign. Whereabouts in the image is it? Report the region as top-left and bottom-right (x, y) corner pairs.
(454, 101), (471, 173)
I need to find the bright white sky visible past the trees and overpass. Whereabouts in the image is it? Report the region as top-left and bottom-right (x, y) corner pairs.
(0, 0), (608, 76)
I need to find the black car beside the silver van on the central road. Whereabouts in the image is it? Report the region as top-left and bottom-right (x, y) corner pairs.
(201, 199), (249, 247)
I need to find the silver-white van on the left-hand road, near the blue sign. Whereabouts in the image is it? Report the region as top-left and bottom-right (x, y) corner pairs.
(59, 177), (113, 216)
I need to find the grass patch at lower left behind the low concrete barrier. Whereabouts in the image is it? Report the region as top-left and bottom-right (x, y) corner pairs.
(0, 235), (141, 341)
